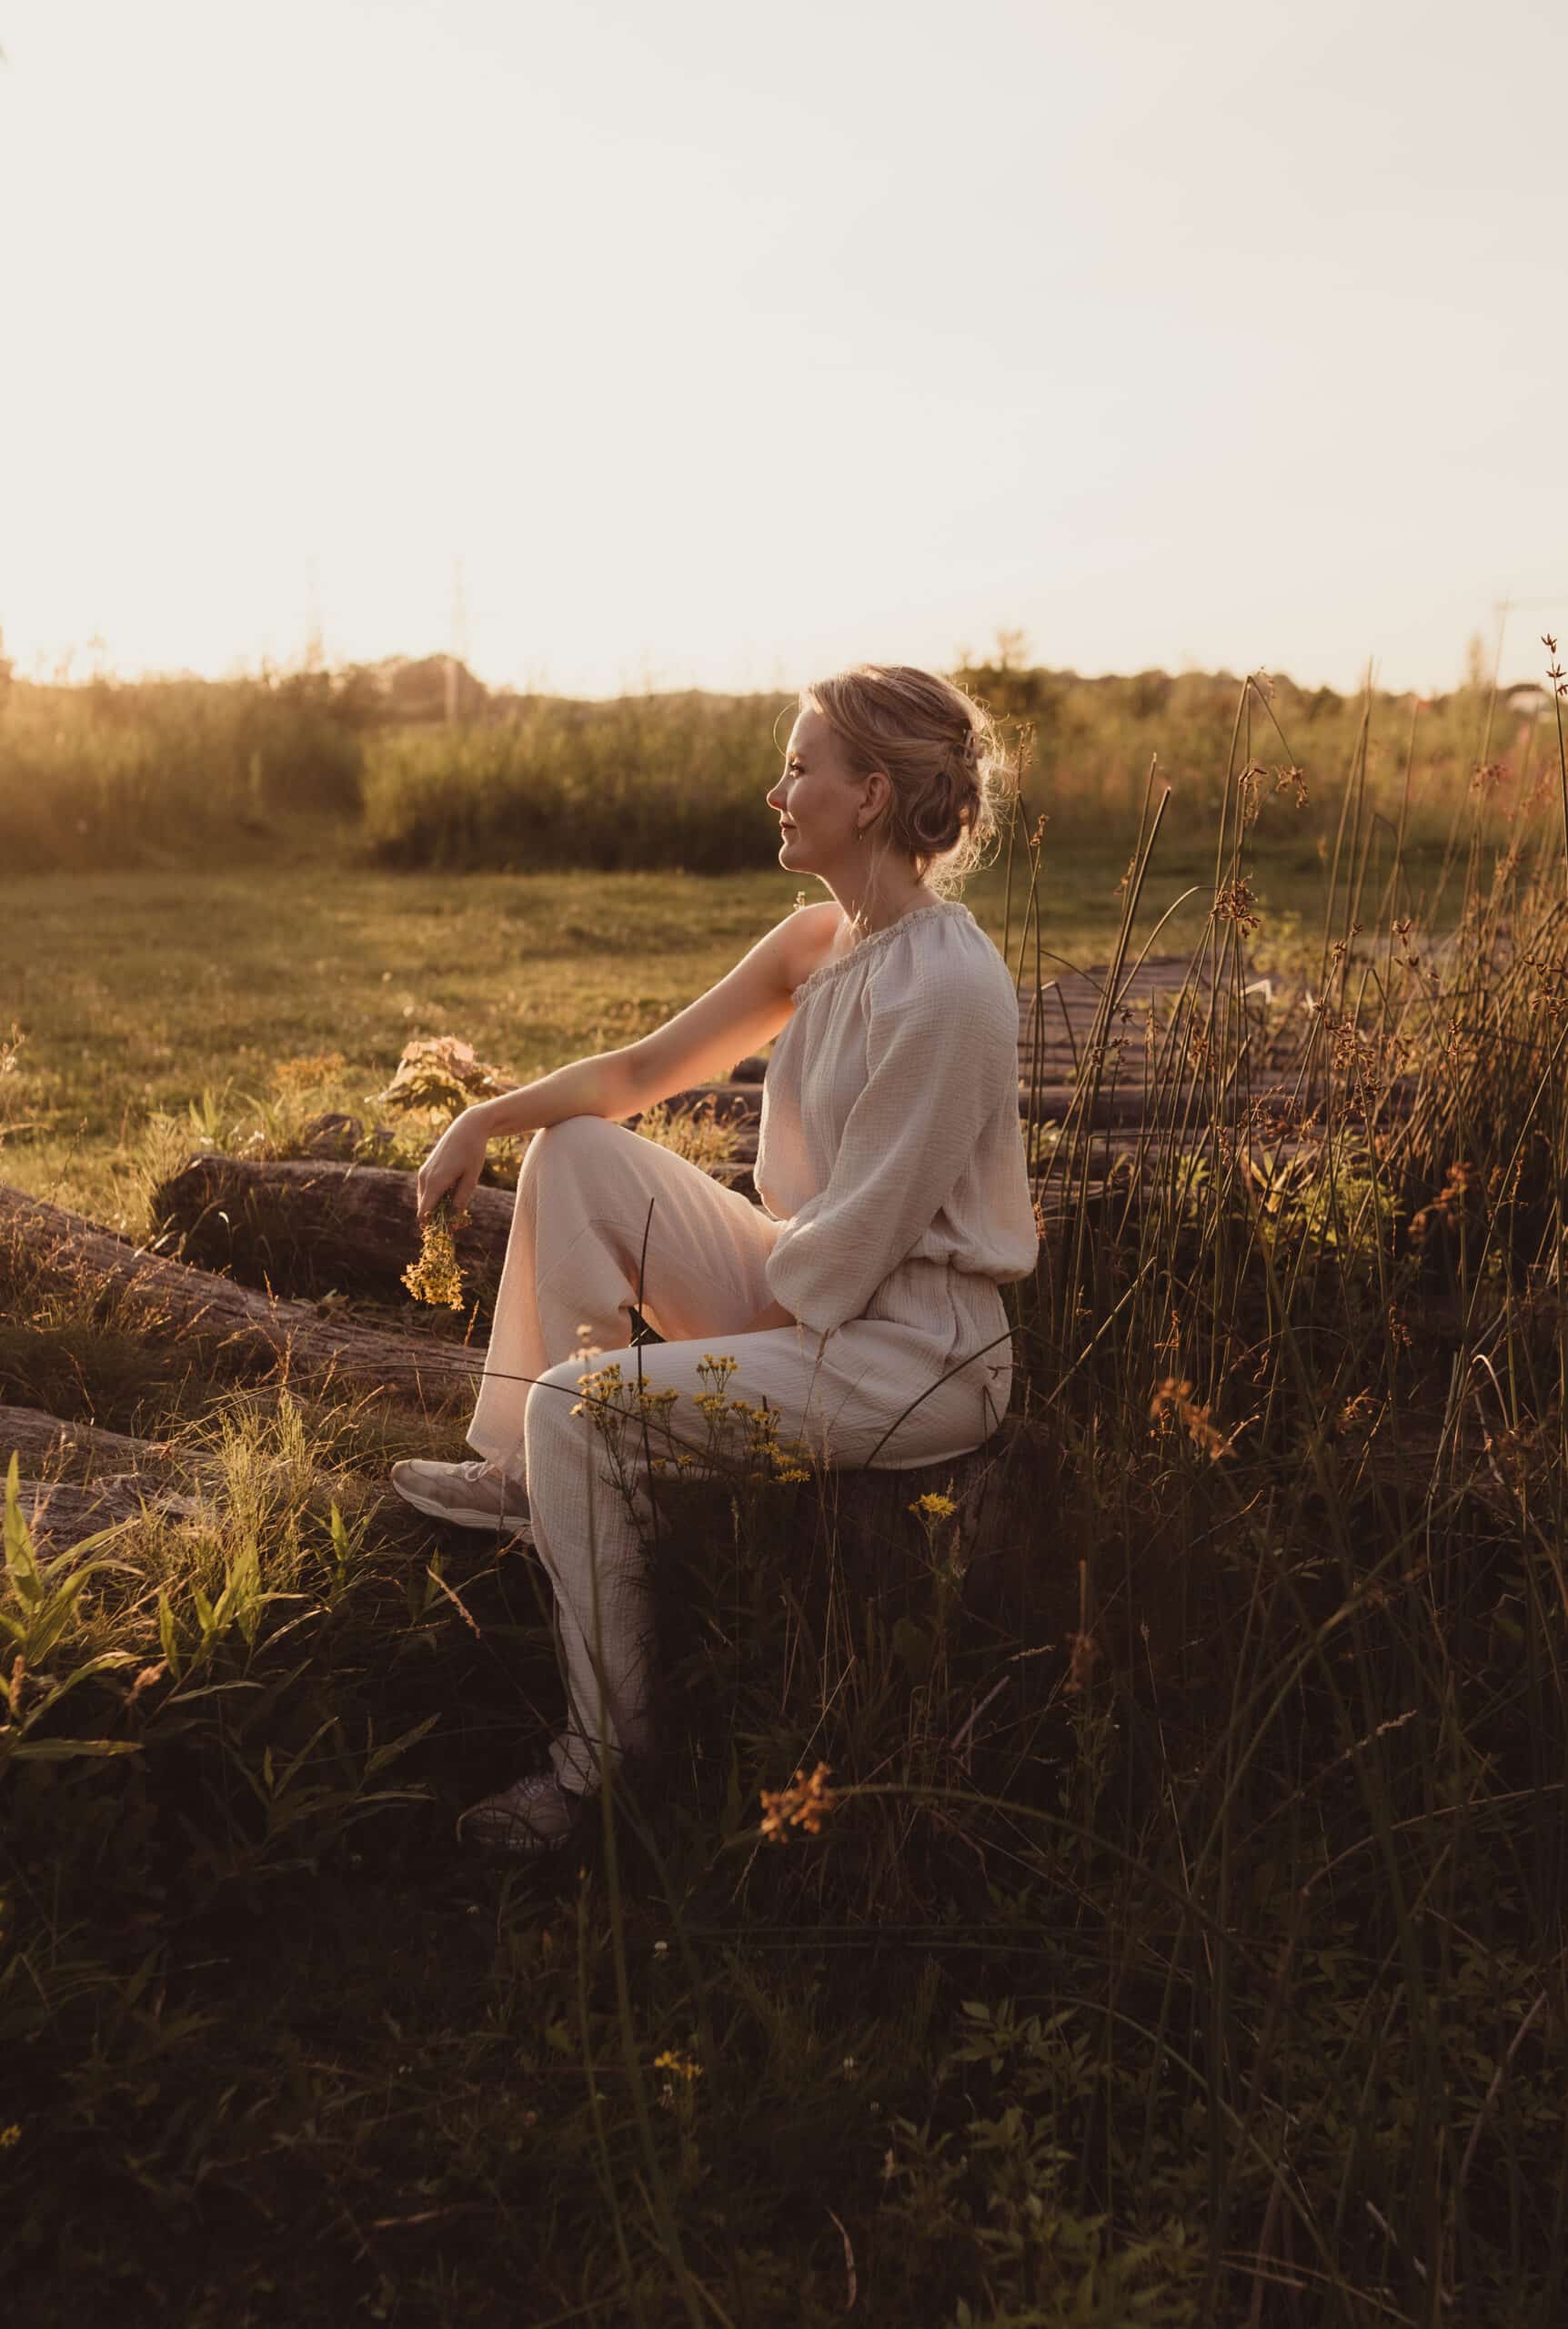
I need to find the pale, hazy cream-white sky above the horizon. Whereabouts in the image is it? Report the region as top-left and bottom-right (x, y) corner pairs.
(0, 0), (1568, 694)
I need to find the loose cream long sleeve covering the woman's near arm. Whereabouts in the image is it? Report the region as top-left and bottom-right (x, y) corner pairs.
(767, 932), (1034, 1332)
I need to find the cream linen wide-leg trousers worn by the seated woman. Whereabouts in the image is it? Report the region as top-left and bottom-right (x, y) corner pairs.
(468, 1115), (1011, 1789)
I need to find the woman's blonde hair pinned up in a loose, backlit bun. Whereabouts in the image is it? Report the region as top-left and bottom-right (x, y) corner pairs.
(799, 664), (1011, 897)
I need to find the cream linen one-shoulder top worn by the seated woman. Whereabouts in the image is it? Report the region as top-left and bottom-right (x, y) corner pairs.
(755, 899), (1040, 1335)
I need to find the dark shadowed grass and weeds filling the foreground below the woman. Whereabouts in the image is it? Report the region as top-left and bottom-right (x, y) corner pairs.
(0, 754), (1568, 2329)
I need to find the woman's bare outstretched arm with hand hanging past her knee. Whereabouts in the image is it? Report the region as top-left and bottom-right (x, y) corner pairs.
(417, 902), (843, 1220)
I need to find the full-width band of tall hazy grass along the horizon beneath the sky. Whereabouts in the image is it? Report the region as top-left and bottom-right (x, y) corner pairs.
(0, 664), (1554, 873)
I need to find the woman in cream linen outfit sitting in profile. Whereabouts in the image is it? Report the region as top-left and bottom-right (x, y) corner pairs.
(391, 664), (1037, 1851)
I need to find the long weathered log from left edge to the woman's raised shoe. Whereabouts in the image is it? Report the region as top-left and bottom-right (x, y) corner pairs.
(0, 1185), (482, 1406)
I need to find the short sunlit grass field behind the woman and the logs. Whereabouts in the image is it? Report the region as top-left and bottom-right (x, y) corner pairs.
(0, 812), (1456, 1235)
